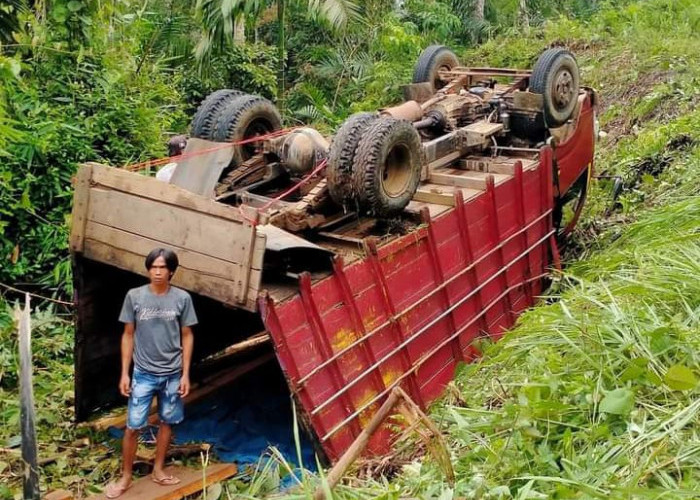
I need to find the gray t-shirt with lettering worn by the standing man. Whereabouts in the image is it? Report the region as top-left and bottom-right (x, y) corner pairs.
(119, 285), (197, 375)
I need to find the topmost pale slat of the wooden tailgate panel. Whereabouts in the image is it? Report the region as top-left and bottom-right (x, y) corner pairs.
(87, 163), (244, 222)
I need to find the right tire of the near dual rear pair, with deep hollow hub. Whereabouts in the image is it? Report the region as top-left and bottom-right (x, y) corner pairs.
(353, 117), (421, 217)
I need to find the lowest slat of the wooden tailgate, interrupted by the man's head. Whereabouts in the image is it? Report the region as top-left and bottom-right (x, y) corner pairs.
(83, 239), (261, 311)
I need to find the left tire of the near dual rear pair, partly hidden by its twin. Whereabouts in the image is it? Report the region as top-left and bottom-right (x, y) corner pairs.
(326, 113), (378, 205)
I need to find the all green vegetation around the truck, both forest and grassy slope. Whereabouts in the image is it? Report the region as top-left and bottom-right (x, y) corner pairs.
(0, 0), (700, 498)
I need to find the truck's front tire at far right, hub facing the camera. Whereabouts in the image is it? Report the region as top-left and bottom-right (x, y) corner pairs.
(530, 48), (580, 128)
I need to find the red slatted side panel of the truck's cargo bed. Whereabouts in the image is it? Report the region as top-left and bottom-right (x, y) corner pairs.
(261, 148), (553, 461)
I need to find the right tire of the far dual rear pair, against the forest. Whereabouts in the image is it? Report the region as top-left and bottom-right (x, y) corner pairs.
(214, 94), (282, 167)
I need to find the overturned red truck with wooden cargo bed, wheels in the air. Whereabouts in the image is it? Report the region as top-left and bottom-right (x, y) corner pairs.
(70, 46), (596, 462)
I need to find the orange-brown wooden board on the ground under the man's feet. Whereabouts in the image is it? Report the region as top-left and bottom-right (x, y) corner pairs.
(89, 464), (238, 500)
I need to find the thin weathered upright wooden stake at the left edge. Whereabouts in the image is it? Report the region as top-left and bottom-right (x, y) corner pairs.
(15, 294), (39, 500)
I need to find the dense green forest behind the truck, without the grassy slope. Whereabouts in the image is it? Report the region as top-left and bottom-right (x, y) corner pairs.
(0, 0), (598, 299)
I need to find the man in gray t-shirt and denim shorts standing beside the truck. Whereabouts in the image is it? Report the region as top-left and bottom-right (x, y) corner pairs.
(105, 248), (197, 498)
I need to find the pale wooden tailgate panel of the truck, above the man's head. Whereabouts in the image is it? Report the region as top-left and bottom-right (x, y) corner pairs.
(70, 164), (265, 311)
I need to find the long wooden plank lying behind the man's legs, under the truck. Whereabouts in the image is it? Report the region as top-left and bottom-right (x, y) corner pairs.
(85, 353), (275, 430)
